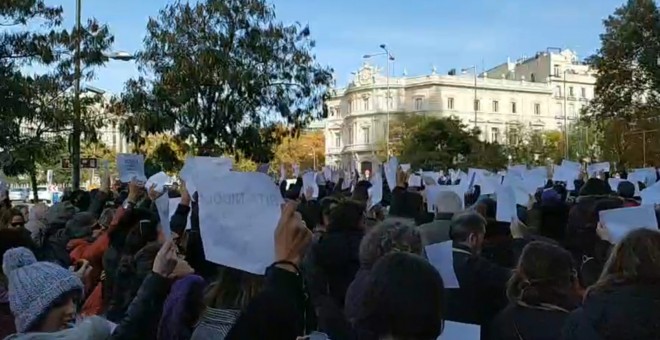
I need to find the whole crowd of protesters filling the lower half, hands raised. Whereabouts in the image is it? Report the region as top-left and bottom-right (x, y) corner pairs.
(0, 163), (660, 340)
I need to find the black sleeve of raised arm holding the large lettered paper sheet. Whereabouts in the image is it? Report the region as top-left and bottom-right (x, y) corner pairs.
(225, 267), (315, 340)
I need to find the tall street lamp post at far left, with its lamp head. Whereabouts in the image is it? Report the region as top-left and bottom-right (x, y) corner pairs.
(71, 0), (135, 190)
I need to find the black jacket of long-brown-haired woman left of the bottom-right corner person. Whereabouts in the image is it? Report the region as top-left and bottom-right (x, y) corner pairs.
(489, 304), (569, 340)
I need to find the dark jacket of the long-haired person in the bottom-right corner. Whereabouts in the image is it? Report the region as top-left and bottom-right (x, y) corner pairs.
(562, 285), (660, 340)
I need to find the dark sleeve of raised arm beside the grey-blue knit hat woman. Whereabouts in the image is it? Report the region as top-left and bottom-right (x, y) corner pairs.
(111, 273), (170, 340)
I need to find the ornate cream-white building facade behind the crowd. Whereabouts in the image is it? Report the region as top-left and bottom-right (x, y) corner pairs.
(324, 49), (595, 172)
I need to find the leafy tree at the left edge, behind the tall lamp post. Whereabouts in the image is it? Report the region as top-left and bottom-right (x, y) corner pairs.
(0, 0), (114, 197)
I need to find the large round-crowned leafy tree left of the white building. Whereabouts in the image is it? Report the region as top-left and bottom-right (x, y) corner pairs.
(122, 0), (332, 162)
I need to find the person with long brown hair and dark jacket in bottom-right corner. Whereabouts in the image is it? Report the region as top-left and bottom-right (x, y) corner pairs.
(563, 226), (660, 340)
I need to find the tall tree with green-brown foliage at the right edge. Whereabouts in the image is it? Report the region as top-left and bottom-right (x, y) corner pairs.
(584, 0), (660, 166)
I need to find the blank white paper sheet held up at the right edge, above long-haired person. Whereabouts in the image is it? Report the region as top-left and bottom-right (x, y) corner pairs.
(599, 205), (658, 243)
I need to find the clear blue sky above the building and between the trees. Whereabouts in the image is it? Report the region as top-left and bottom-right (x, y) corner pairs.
(47, 0), (623, 93)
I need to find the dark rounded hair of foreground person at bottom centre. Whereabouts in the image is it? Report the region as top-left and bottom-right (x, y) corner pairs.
(357, 252), (445, 340)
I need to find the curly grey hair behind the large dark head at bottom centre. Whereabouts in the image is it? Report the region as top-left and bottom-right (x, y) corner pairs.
(360, 218), (422, 269)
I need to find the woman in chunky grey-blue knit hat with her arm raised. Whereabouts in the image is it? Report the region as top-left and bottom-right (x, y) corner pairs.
(2, 242), (191, 340)
